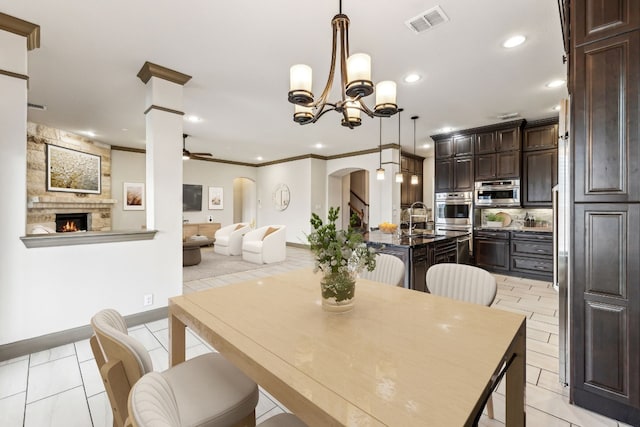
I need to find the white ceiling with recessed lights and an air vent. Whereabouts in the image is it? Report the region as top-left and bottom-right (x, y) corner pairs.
(0, 0), (566, 163)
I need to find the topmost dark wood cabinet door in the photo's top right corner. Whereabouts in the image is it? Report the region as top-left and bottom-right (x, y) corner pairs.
(570, 0), (640, 46)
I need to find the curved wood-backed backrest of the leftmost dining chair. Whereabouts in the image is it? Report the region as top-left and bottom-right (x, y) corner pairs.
(91, 309), (153, 426)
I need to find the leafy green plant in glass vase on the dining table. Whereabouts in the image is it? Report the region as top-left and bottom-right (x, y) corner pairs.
(307, 207), (376, 312)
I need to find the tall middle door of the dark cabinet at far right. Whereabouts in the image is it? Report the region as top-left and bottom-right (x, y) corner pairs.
(572, 31), (640, 202)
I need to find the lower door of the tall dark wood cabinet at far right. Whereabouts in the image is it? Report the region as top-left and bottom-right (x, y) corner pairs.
(570, 203), (640, 425)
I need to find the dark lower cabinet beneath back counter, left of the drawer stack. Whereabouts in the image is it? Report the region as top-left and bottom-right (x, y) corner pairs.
(473, 230), (510, 273)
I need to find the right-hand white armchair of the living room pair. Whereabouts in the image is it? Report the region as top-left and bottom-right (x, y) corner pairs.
(242, 225), (287, 264)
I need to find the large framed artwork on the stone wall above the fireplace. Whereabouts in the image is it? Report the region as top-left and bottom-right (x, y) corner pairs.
(47, 144), (102, 194)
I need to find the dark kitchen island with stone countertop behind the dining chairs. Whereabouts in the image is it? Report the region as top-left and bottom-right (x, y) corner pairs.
(364, 231), (469, 292)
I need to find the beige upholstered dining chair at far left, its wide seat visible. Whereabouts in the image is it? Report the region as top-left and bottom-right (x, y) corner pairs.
(90, 309), (258, 427)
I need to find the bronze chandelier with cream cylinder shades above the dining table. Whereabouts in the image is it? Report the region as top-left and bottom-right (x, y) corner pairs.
(289, 0), (398, 129)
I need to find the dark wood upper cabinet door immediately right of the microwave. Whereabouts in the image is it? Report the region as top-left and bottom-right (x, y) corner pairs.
(520, 149), (558, 208)
